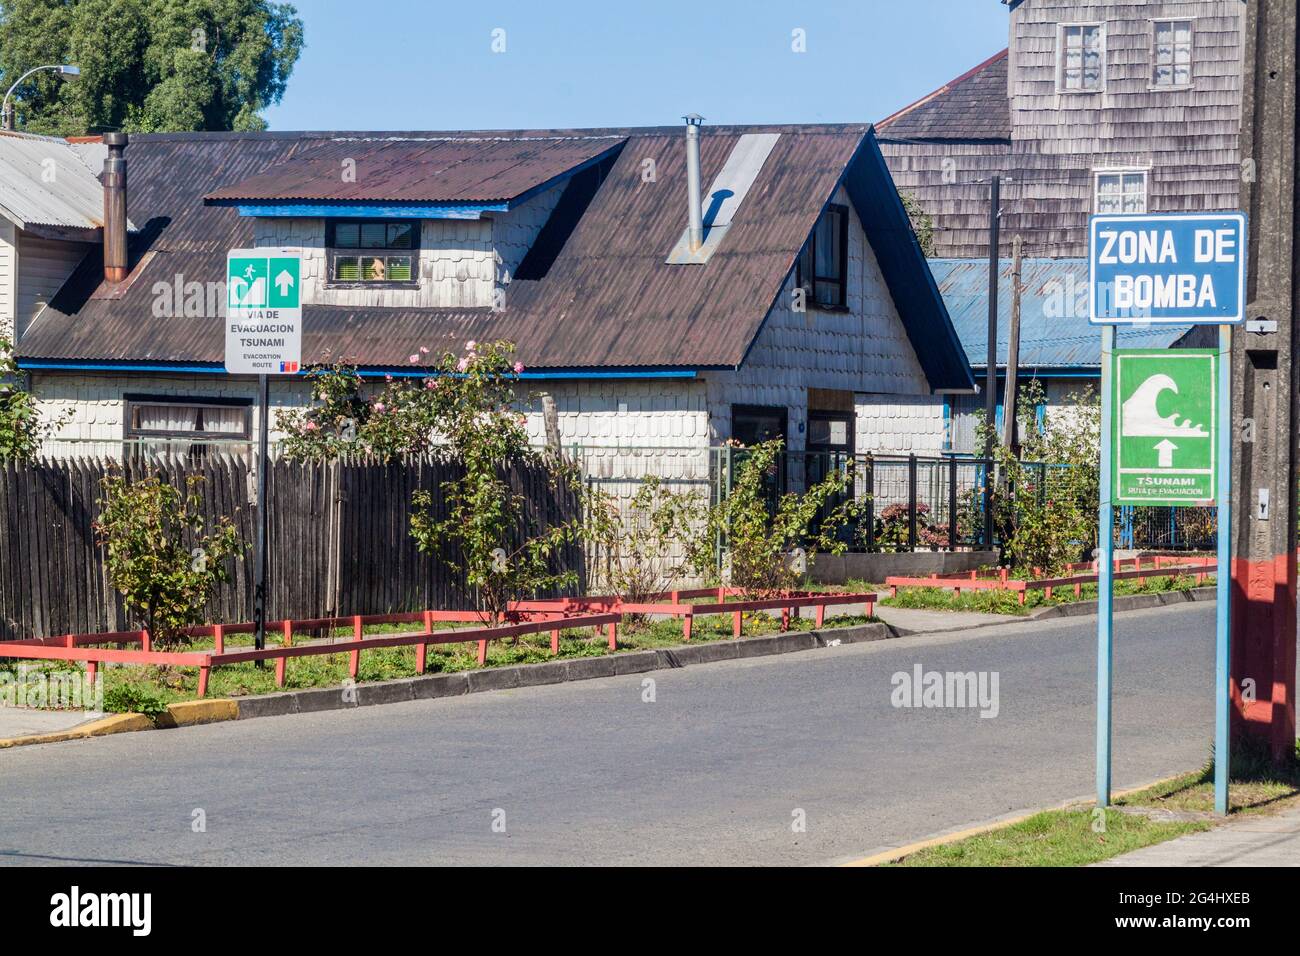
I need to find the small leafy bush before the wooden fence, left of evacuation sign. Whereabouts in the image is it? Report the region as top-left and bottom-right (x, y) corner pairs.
(95, 475), (244, 648)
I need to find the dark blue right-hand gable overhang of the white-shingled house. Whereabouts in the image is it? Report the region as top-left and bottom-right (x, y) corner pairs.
(844, 126), (975, 389)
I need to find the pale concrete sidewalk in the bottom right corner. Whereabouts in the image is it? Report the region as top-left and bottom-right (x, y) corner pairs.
(1093, 806), (1300, 866)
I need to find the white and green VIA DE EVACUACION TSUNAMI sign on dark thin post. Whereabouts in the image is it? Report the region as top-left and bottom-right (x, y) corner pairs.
(225, 248), (303, 650)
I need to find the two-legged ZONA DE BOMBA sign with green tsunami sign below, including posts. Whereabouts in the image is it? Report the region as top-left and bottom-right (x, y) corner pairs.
(1089, 213), (1247, 814)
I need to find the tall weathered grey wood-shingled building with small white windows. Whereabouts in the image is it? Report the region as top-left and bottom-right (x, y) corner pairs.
(879, 0), (1245, 258)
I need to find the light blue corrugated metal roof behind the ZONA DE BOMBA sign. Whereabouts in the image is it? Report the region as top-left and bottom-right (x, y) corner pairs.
(930, 259), (1192, 369)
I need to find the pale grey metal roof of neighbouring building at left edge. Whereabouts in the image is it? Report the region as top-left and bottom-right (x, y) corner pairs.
(0, 133), (104, 229)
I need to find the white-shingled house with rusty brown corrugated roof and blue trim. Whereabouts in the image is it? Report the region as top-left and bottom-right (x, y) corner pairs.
(7, 126), (974, 477)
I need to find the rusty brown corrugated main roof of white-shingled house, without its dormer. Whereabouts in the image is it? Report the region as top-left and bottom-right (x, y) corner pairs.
(18, 126), (971, 388)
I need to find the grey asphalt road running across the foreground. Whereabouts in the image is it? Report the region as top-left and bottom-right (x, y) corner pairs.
(0, 604), (1214, 865)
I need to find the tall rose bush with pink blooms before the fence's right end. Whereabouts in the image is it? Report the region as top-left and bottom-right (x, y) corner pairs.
(411, 342), (585, 623)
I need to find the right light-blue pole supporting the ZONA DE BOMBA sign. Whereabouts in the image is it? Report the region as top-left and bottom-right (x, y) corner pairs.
(1214, 325), (1232, 814)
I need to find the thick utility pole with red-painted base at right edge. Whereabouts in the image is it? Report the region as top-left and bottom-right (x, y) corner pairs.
(1219, 0), (1300, 762)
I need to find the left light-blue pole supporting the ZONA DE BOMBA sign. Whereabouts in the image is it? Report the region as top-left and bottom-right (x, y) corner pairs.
(1097, 325), (1115, 806)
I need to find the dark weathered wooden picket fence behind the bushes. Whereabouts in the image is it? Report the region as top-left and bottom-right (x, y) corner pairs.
(0, 454), (585, 640)
